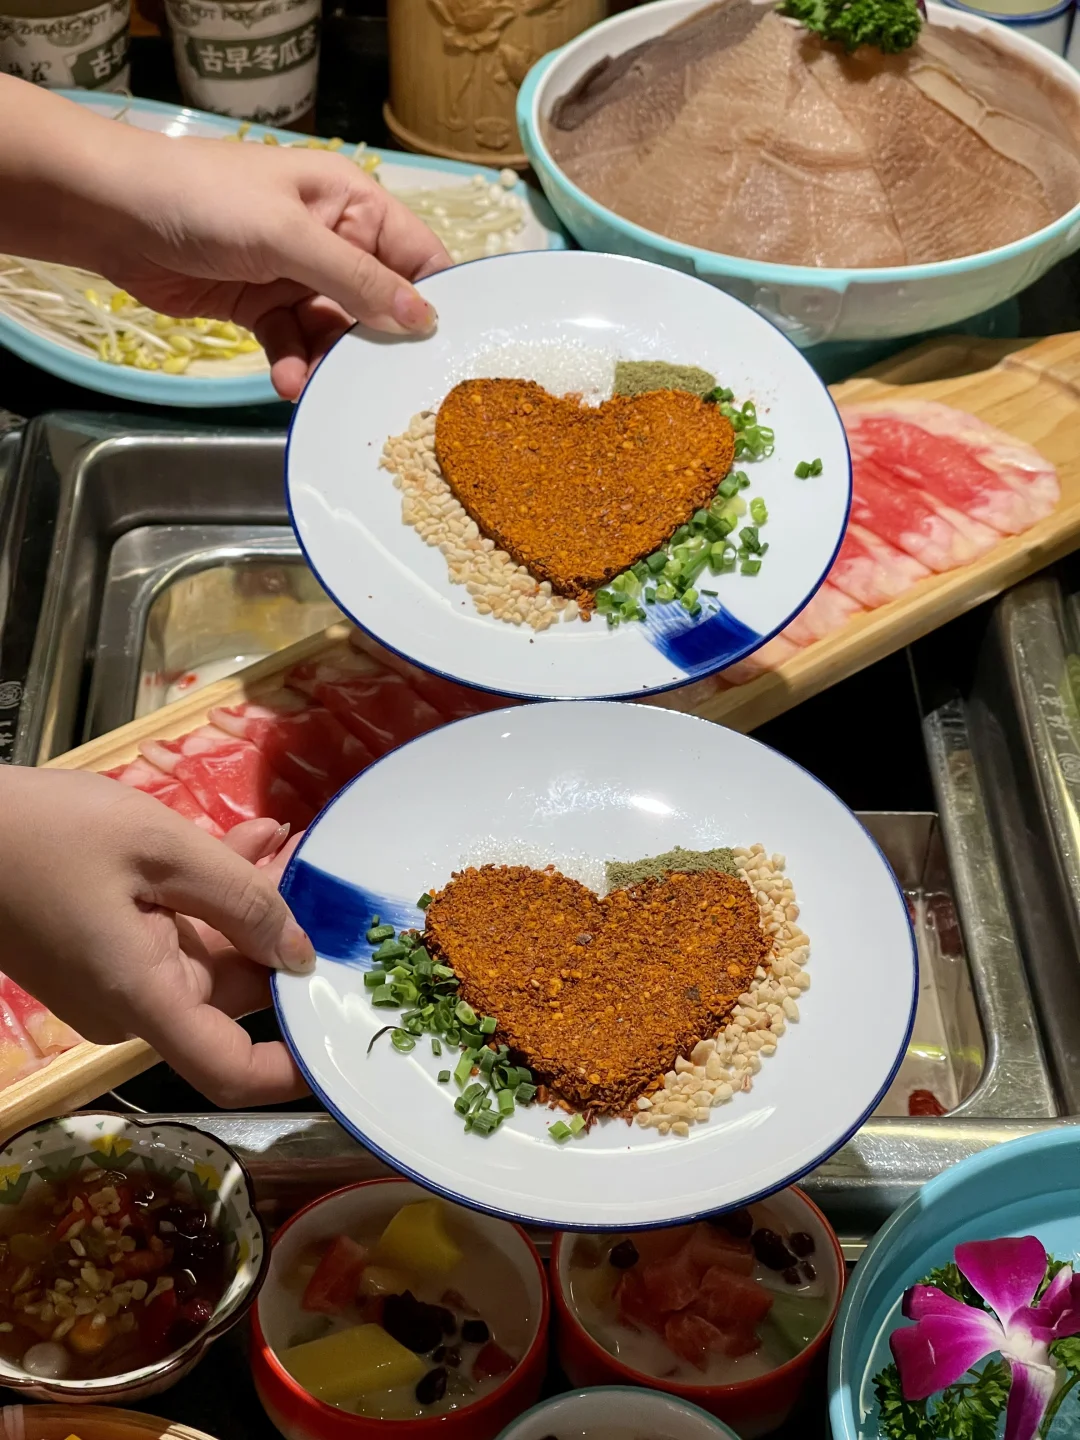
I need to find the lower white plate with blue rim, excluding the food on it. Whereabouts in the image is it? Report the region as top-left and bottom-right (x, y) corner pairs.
(274, 701), (919, 1230)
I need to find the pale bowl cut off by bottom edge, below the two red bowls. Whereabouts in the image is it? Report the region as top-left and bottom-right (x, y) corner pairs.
(498, 1385), (736, 1440)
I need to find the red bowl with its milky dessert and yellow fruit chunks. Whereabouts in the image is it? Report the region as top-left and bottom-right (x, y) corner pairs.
(251, 1179), (550, 1440)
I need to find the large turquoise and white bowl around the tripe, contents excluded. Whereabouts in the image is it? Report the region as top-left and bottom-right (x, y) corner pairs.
(517, 0), (1080, 350)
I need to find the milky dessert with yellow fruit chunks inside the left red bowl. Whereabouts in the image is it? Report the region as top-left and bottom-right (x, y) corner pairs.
(276, 1200), (536, 1420)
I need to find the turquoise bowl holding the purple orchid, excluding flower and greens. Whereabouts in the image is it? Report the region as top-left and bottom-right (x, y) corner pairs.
(829, 1125), (1080, 1440)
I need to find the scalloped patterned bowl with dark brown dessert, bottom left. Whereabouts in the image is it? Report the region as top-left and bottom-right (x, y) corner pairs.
(0, 1112), (269, 1405)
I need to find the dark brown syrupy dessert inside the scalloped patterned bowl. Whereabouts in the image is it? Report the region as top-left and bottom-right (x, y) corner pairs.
(0, 1169), (228, 1380)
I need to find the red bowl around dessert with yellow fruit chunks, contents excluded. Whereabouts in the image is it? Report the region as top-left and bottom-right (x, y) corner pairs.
(251, 1179), (550, 1440)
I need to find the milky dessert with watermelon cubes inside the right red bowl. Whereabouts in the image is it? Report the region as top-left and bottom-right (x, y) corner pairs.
(566, 1202), (835, 1385)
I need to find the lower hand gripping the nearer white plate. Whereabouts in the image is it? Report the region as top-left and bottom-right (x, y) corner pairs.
(0, 766), (315, 1109)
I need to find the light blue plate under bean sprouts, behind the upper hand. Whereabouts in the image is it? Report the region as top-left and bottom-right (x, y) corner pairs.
(0, 91), (566, 408)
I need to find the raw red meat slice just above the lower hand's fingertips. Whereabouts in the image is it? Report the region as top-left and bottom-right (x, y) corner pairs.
(140, 724), (315, 831)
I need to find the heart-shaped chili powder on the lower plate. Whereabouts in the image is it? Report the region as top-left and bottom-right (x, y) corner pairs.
(425, 865), (770, 1113)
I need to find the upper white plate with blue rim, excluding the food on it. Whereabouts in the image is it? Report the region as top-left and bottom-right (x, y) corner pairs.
(287, 251), (851, 700)
